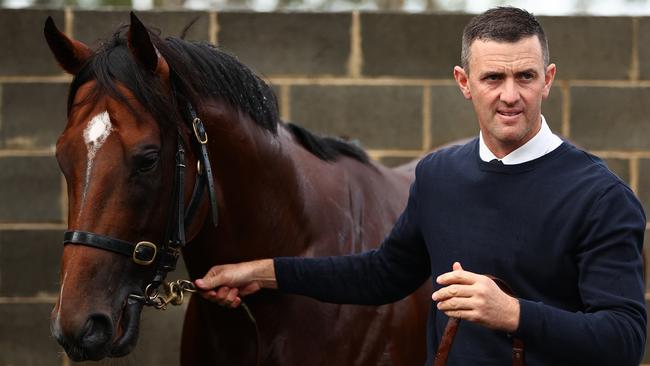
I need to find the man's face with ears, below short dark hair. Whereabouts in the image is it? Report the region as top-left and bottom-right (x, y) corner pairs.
(454, 36), (555, 157)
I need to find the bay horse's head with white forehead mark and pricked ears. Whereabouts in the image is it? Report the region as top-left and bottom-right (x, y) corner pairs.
(45, 16), (192, 361)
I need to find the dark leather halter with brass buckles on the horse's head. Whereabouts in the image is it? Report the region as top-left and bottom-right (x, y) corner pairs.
(63, 103), (219, 306)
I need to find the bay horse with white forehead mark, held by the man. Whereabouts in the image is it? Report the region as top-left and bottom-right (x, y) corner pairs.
(44, 13), (431, 366)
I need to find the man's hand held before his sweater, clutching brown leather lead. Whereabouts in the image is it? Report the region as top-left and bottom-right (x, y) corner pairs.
(431, 262), (520, 332)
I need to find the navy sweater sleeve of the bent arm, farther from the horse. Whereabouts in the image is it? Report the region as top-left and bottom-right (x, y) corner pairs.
(515, 183), (646, 366)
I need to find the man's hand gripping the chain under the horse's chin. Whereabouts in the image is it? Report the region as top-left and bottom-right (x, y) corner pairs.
(194, 259), (278, 308)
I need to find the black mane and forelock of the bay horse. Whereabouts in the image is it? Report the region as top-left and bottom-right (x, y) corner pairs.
(68, 26), (368, 163)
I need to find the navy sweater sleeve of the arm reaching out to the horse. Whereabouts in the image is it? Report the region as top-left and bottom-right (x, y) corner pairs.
(274, 164), (431, 305)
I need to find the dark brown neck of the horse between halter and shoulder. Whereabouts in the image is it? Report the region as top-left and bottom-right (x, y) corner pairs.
(187, 107), (305, 261)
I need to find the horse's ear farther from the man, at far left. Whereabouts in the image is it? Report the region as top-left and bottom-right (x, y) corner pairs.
(43, 17), (93, 75)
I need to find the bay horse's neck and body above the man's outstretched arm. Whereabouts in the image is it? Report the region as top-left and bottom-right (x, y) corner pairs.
(188, 102), (408, 271)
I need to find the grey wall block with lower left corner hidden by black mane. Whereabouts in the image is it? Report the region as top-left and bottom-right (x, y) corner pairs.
(218, 12), (352, 76)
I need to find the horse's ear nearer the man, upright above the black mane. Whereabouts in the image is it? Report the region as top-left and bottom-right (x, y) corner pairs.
(128, 12), (169, 76)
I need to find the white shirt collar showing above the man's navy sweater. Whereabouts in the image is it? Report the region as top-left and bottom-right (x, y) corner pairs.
(478, 116), (562, 165)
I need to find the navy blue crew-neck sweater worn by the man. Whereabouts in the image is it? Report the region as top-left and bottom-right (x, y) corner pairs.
(275, 139), (646, 366)
